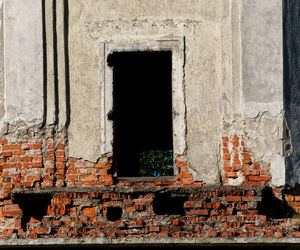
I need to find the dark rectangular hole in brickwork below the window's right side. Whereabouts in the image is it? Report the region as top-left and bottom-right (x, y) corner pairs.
(153, 194), (188, 215)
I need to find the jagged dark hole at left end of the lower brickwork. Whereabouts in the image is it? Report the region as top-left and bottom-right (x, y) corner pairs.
(13, 194), (52, 232)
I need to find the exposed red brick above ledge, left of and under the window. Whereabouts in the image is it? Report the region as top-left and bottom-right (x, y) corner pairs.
(0, 139), (203, 189)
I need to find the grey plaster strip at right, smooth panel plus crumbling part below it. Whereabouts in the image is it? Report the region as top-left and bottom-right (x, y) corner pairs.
(241, 0), (285, 186)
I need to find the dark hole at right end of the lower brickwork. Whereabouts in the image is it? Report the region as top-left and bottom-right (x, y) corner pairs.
(257, 187), (295, 219)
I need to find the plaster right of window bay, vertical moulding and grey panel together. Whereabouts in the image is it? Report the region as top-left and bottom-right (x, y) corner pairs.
(221, 0), (285, 186)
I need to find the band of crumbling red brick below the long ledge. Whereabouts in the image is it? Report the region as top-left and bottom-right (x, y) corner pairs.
(0, 188), (300, 238)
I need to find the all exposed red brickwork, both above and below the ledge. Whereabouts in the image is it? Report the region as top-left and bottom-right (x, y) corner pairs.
(0, 136), (300, 239)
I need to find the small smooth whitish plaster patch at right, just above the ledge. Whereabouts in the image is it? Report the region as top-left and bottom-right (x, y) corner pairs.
(271, 154), (285, 187)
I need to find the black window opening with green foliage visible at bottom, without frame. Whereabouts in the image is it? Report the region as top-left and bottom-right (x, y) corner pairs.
(107, 51), (173, 177)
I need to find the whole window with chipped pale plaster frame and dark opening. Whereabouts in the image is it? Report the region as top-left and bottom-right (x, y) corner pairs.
(101, 40), (185, 177)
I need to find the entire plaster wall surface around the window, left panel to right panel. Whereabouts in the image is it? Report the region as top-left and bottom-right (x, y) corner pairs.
(0, 0), (285, 186)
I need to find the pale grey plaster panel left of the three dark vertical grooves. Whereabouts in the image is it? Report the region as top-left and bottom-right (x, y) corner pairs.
(3, 0), (43, 125)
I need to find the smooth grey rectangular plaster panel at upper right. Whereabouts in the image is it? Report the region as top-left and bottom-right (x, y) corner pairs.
(241, 0), (283, 117)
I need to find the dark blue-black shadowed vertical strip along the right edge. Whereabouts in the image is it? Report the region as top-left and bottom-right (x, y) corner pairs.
(283, 0), (300, 187)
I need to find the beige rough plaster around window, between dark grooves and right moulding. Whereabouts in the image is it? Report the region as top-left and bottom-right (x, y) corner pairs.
(69, 0), (221, 183)
